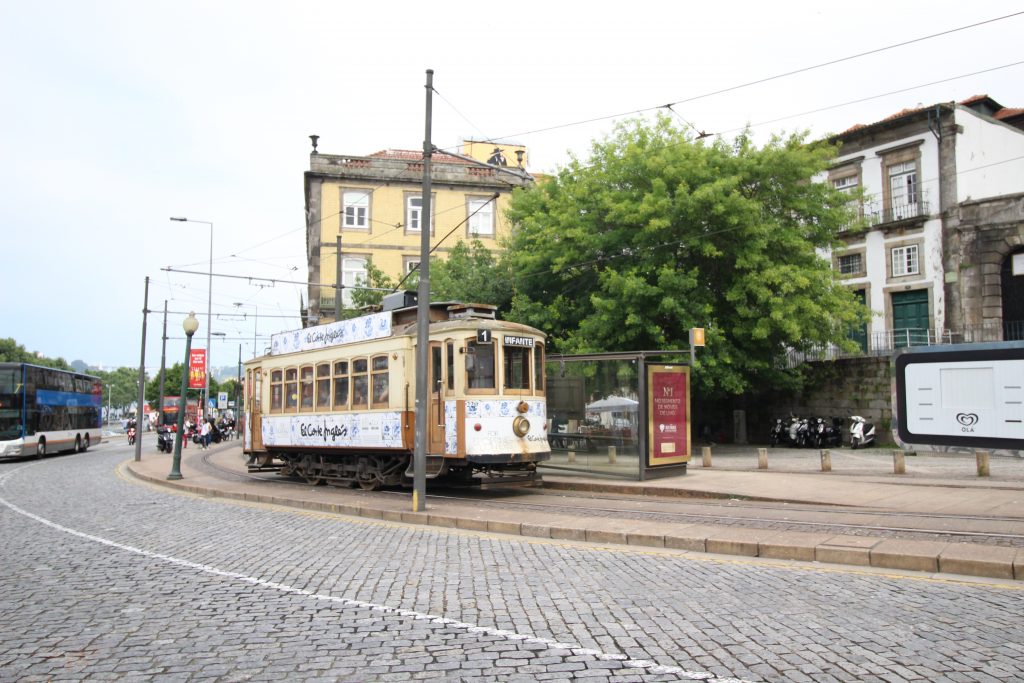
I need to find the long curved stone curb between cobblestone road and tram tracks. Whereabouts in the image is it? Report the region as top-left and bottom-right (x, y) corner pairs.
(124, 461), (1024, 581)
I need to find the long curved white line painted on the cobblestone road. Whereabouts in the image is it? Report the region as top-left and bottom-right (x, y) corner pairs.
(0, 463), (751, 683)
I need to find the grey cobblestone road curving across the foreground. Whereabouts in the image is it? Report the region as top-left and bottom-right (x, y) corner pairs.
(0, 444), (1024, 682)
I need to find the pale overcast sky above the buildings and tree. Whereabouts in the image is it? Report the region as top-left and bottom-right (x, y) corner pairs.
(0, 0), (1024, 369)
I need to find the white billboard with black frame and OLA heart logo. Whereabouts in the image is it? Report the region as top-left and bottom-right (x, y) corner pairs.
(894, 343), (1024, 451)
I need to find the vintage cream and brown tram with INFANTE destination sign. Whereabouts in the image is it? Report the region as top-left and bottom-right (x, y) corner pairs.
(244, 293), (551, 490)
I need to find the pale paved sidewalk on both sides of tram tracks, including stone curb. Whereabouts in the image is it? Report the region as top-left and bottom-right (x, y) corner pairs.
(127, 444), (1024, 581)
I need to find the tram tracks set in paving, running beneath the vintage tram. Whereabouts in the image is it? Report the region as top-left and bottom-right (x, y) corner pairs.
(195, 453), (1024, 548)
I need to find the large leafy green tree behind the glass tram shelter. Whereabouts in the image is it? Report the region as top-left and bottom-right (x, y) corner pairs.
(506, 118), (864, 396)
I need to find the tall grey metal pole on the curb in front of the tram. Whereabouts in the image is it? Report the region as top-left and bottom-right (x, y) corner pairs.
(413, 69), (434, 512)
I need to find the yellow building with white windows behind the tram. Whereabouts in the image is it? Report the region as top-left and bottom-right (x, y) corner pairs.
(305, 136), (534, 325)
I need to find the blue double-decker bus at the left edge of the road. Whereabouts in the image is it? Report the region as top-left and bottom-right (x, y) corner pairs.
(0, 362), (103, 458)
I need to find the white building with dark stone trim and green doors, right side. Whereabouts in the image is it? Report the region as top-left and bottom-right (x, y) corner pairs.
(828, 96), (1024, 351)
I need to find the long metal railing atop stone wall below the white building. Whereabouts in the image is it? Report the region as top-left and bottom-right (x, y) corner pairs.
(785, 321), (1024, 368)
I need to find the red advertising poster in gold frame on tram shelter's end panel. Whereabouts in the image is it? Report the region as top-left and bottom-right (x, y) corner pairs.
(647, 365), (690, 467)
